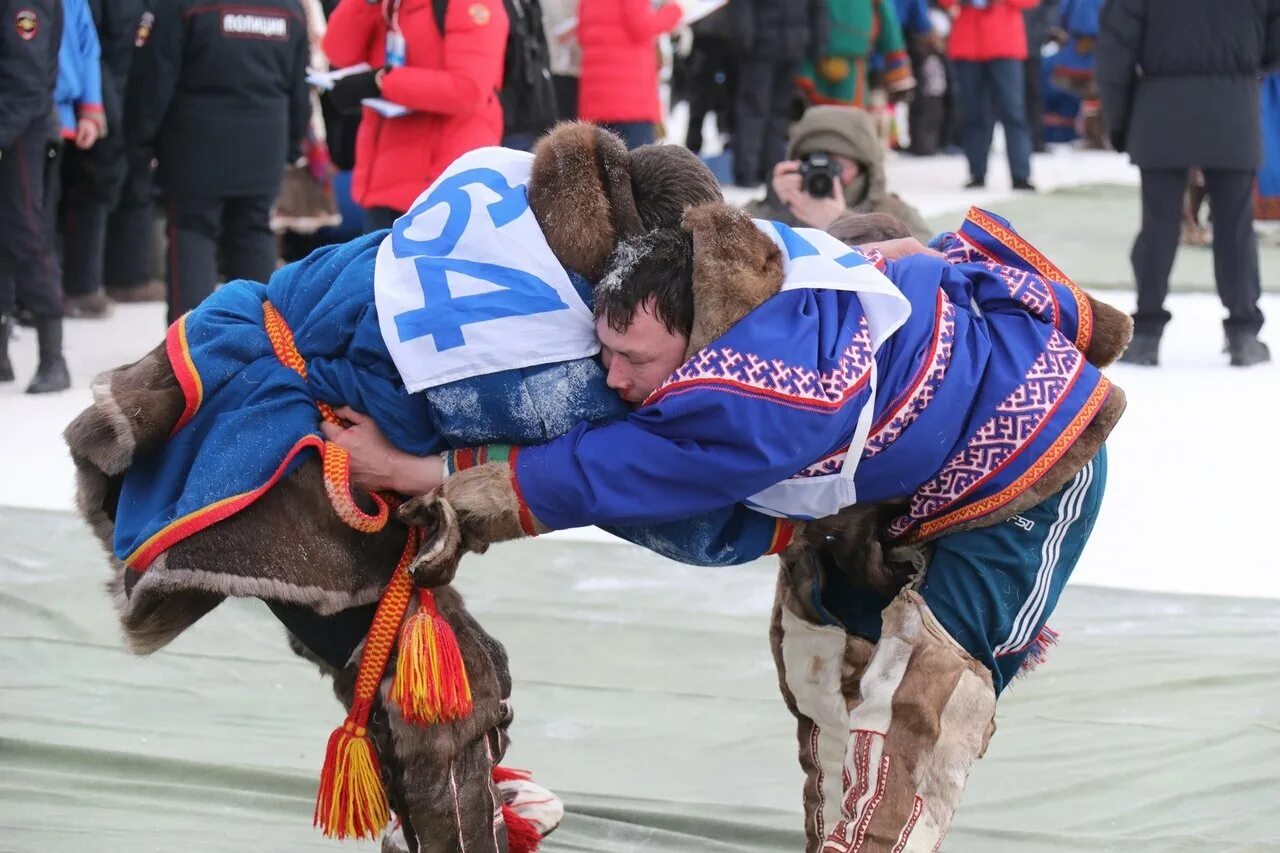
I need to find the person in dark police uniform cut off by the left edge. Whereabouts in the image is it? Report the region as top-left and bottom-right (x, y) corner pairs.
(0, 0), (70, 393)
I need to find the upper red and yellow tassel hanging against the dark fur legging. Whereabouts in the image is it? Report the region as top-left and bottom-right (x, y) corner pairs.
(392, 589), (471, 724)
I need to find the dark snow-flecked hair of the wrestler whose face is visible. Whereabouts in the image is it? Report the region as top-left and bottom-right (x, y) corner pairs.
(595, 228), (694, 338)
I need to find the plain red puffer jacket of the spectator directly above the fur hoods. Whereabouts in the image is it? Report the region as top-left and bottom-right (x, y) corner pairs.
(577, 0), (681, 122)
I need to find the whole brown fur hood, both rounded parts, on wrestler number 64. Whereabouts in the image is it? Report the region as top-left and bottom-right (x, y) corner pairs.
(529, 122), (722, 282)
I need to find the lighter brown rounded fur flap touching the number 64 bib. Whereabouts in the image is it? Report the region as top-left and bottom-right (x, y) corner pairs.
(529, 122), (643, 283)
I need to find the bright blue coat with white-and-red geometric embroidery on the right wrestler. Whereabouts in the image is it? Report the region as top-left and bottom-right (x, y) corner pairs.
(516, 210), (1111, 540)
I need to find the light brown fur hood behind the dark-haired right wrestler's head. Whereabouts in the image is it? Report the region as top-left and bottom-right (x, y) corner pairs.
(684, 202), (783, 357)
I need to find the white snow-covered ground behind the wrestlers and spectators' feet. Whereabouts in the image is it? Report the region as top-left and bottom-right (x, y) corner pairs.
(0, 151), (1280, 598)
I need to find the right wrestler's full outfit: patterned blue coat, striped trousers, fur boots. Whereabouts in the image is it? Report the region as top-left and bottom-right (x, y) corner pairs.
(404, 205), (1130, 853)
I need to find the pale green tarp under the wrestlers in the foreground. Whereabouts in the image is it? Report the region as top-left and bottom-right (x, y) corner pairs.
(0, 510), (1280, 853)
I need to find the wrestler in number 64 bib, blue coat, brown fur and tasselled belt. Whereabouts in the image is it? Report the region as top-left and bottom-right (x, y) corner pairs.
(67, 126), (791, 852)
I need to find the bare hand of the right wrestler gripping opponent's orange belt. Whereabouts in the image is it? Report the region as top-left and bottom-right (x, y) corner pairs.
(320, 406), (444, 494)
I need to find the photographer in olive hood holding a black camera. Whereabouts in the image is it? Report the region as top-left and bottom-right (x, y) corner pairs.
(746, 106), (933, 243)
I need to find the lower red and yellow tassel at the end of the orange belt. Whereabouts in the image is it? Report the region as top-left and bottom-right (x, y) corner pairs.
(312, 707), (390, 839)
